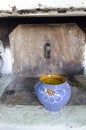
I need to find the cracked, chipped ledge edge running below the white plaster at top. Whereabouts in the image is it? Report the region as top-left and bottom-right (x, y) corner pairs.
(0, 8), (86, 18)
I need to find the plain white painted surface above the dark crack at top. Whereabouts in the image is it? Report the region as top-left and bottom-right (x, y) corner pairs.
(0, 0), (86, 11)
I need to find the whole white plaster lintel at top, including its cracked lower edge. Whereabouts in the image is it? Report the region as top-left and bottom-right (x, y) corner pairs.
(0, 0), (86, 17)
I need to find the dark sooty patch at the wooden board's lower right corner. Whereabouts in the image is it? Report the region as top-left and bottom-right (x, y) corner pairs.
(62, 62), (84, 76)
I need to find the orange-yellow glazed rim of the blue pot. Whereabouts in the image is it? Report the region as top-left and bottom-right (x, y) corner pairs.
(39, 74), (67, 86)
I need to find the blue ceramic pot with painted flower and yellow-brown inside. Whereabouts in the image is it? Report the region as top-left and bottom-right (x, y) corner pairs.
(35, 75), (71, 111)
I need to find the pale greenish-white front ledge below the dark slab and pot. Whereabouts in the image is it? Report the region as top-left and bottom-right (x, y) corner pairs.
(0, 105), (86, 130)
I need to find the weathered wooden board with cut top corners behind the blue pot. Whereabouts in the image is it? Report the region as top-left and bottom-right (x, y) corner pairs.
(9, 23), (85, 77)
